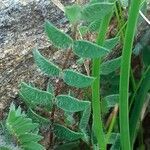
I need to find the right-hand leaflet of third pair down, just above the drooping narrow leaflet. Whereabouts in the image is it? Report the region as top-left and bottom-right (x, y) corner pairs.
(56, 95), (90, 112)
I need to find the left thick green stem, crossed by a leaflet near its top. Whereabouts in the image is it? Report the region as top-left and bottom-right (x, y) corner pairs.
(92, 14), (111, 150)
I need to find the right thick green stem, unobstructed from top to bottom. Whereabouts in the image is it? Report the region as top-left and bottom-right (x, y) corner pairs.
(119, 0), (141, 150)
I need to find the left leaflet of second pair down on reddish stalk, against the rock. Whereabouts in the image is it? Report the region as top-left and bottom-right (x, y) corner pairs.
(33, 49), (61, 76)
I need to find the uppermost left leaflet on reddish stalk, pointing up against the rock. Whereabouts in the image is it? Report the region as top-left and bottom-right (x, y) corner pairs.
(45, 21), (73, 49)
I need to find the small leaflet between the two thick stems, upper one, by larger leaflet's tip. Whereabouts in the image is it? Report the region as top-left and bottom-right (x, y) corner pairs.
(104, 37), (120, 50)
